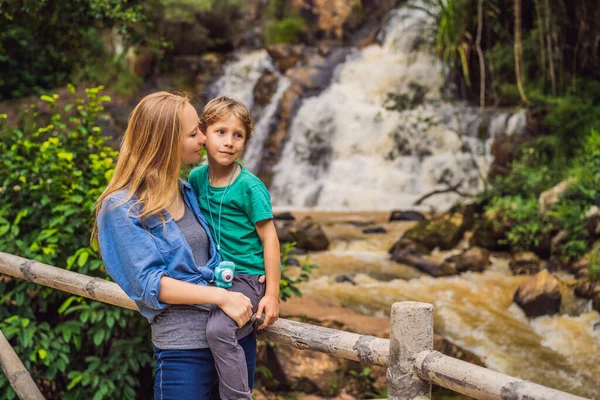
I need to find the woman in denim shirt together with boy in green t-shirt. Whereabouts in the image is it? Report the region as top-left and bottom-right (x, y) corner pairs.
(92, 92), (281, 400)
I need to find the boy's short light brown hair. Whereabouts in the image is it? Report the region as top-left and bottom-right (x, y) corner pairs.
(199, 96), (254, 143)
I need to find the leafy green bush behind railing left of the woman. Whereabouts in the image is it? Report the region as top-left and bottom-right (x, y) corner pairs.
(0, 86), (151, 399)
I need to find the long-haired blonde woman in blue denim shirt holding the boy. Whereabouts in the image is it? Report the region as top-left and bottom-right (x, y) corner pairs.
(92, 92), (256, 399)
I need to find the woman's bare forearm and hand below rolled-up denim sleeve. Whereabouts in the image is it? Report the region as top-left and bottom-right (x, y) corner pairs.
(158, 276), (252, 328)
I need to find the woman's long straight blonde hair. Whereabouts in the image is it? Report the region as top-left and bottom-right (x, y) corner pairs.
(91, 92), (189, 243)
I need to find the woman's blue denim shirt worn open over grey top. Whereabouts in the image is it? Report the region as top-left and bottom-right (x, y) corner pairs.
(97, 181), (221, 322)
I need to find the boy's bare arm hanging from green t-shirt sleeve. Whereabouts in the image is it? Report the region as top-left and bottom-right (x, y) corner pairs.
(256, 219), (281, 329)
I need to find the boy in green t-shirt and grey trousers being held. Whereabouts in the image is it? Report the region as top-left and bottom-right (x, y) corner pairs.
(189, 97), (281, 399)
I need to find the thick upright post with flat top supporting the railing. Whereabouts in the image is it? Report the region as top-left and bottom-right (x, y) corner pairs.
(386, 301), (433, 400)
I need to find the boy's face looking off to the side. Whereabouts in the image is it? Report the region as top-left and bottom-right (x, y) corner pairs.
(206, 113), (246, 166)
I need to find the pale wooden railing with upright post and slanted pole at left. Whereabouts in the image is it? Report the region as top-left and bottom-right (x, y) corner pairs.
(0, 252), (583, 400)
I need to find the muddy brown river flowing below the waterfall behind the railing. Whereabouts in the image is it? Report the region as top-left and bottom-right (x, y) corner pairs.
(282, 211), (600, 399)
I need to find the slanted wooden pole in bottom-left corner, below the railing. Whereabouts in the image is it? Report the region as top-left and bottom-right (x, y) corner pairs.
(0, 331), (44, 400)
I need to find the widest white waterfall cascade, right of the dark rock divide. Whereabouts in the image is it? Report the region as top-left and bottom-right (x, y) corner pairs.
(270, 7), (523, 210)
